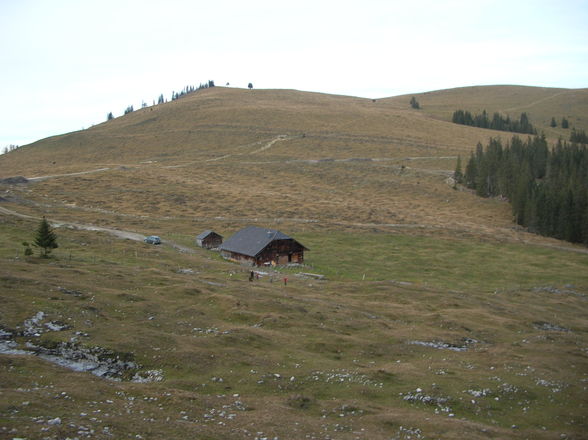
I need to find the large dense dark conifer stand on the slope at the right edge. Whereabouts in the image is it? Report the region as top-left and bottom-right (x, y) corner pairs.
(455, 136), (588, 245)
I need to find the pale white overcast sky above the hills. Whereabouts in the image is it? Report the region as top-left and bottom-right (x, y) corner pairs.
(0, 0), (588, 150)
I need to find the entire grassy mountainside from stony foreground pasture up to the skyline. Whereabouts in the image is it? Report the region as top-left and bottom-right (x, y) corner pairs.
(0, 87), (588, 440)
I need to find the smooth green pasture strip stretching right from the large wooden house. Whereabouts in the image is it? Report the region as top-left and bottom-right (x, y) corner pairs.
(299, 233), (588, 292)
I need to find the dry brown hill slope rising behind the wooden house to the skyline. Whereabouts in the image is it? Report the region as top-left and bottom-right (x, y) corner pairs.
(0, 87), (584, 246)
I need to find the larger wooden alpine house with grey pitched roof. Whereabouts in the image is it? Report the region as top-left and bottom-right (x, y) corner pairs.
(219, 226), (308, 266)
